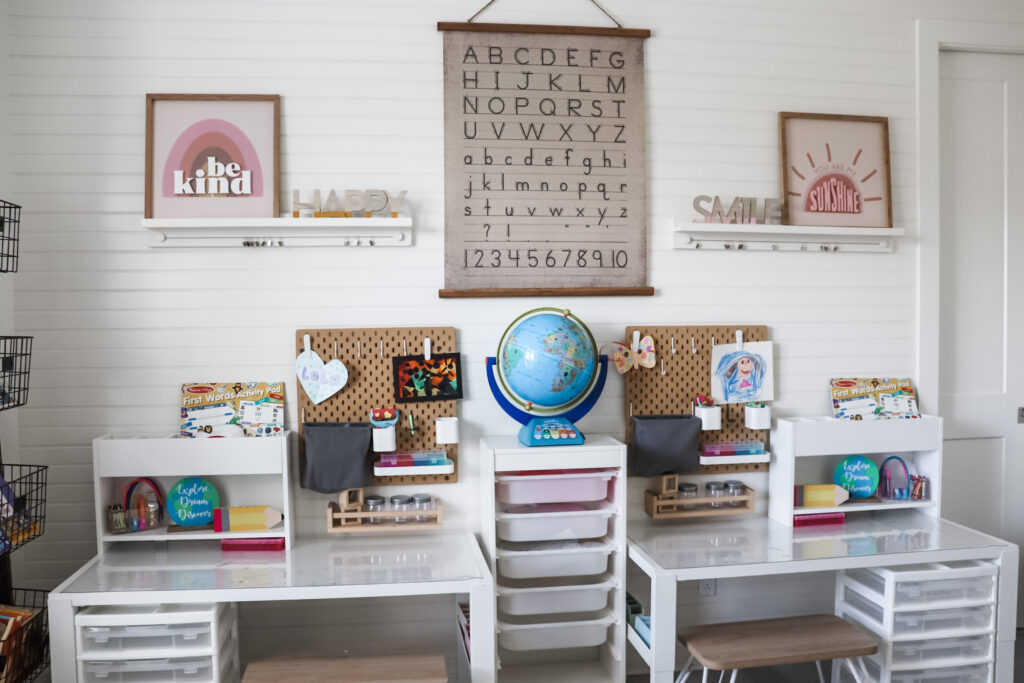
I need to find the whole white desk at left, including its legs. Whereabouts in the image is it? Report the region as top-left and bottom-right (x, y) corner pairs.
(49, 533), (495, 683)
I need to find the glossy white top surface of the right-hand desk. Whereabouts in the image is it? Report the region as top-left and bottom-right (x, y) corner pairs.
(628, 510), (1014, 581)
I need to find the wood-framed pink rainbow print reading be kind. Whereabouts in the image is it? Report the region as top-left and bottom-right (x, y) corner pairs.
(145, 94), (281, 218)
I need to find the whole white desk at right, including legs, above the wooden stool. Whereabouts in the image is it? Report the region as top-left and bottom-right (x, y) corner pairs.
(628, 511), (1018, 683)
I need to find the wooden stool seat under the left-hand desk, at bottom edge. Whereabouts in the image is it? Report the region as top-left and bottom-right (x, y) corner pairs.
(242, 654), (447, 683)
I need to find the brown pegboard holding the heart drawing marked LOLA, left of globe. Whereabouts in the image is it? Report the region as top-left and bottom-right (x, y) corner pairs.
(295, 328), (463, 485)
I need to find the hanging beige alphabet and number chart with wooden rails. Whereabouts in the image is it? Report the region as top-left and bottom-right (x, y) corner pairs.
(438, 24), (650, 295)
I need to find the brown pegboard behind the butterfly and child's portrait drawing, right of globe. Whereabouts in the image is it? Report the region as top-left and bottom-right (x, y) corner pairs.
(626, 325), (769, 474)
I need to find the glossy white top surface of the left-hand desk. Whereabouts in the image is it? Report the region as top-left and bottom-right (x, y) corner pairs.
(57, 533), (490, 600)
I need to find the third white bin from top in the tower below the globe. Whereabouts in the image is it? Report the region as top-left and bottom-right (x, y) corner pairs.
(498, 541), (615, 579)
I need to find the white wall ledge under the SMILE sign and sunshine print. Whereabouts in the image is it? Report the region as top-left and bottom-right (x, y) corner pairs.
(673, 223), (905, 252)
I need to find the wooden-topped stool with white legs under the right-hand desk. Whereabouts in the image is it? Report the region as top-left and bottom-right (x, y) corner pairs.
(676, 614), (879, 683)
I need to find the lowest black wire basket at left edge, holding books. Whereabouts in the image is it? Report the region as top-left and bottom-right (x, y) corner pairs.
(0, 588), (50, 683)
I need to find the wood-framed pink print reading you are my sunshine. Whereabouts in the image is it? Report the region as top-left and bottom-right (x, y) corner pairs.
(778, 112), (893, 227)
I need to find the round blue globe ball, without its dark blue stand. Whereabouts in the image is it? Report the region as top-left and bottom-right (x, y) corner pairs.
(497, 308), (597, 414)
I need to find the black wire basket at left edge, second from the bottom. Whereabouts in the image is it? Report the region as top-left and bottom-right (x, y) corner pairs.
(0, 465), (47, 557)
